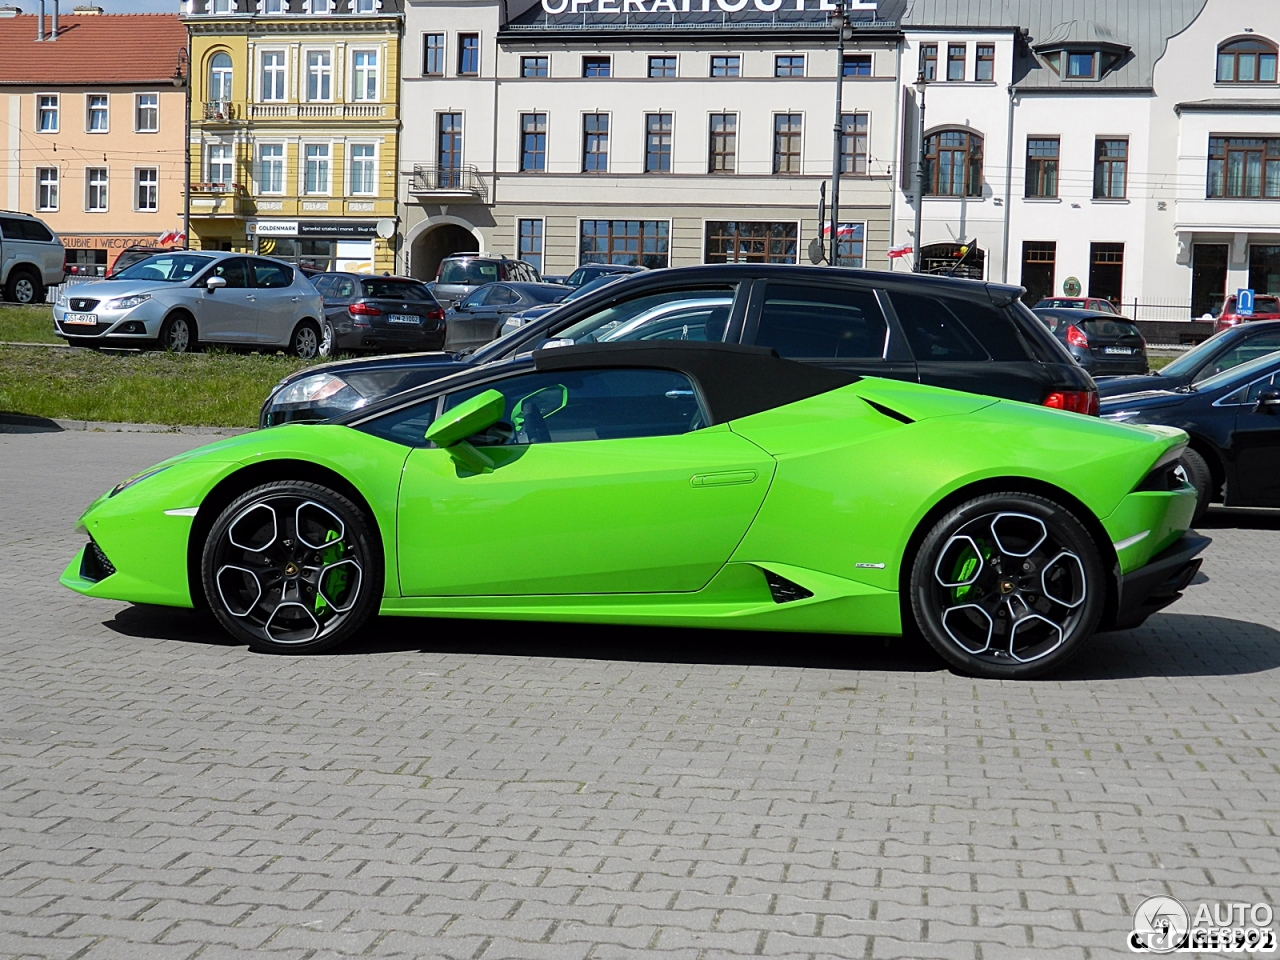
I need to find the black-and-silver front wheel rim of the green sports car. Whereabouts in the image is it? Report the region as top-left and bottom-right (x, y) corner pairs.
(214, 494), (365, 646)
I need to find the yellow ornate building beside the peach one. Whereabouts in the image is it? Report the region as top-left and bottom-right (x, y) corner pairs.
(183, 0), (402, 273)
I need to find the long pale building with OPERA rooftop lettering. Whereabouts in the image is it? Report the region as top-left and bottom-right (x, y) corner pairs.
(399, 0), (899, 278)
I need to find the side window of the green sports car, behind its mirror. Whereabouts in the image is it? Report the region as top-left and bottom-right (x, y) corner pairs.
(444, 369), (707, 447)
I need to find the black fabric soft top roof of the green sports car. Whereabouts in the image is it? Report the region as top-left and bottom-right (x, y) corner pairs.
(534, 340), (861, 424)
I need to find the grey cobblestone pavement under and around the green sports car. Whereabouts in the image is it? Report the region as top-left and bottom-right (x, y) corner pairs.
(0, 433), (1280, 960)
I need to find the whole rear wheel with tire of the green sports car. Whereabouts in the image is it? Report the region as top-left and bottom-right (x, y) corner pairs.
(909, 493), (1108, 680)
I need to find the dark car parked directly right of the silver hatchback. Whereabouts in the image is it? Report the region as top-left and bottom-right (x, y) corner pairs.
(310, 273), (444, 357)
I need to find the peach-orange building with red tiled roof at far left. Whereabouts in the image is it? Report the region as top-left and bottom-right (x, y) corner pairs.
(0, 8), (187, 276)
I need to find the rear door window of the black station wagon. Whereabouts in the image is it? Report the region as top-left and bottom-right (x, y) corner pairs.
(755, 283), (888, 360)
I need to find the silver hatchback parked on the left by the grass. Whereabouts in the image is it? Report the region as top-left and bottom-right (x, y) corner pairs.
(54, 251), (324, 360)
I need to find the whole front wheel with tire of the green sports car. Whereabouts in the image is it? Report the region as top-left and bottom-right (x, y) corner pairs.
(200, 480), (383, 653)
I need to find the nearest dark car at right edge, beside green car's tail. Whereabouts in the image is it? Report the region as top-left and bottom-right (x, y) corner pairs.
(1102, 353), (1280, 516)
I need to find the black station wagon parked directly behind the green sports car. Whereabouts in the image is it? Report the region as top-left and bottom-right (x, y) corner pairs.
(261, 264), (1098, 426)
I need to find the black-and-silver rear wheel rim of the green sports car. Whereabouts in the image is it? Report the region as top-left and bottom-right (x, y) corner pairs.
(929, 511), (1088, 666)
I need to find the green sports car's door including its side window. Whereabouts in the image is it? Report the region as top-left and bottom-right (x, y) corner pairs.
(398, 369), (774, 596)
